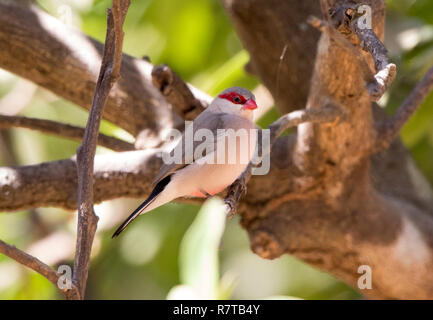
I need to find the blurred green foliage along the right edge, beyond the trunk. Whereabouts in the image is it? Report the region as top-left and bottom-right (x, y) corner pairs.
(384, 0), (433, 184)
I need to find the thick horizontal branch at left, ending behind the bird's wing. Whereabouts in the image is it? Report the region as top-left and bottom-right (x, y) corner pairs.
(0, 149), (162, 211)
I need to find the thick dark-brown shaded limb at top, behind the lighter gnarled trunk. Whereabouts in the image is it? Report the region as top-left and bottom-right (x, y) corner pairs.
(221, 0), (320, 114)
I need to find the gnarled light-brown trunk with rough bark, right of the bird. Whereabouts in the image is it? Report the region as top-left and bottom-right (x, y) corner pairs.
(221, 0), (433, 298)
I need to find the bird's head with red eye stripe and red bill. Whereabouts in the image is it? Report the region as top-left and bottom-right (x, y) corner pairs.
(210, 87), (257, 120)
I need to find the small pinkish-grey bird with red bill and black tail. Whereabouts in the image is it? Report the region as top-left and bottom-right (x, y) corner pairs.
(112, 87), (257, 238)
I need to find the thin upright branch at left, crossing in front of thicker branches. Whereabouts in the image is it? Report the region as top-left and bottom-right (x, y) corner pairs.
(73, 0), (130, 299)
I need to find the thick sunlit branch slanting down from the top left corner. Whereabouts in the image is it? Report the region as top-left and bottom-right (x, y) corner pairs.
(0, 1), (180, 147)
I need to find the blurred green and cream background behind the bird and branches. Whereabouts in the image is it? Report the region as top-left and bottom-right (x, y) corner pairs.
(0, 0), (433, 299)
